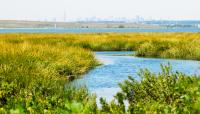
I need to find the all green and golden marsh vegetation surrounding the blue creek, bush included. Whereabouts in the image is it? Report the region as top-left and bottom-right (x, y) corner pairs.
(0, 33), (200, 114)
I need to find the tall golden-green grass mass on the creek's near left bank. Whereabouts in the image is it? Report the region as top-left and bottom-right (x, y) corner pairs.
(0, 40), (96, 113)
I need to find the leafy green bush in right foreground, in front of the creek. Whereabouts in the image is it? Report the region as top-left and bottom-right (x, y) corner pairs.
(100, 65), (200, 114)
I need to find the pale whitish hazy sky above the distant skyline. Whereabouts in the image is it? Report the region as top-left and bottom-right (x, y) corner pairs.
(0, 0), (200, 21)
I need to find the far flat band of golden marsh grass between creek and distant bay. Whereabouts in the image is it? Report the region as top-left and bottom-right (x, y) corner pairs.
(0, 33), (200, 60)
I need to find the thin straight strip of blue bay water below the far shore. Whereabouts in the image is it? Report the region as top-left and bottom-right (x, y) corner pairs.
(0, 28), (200, 33)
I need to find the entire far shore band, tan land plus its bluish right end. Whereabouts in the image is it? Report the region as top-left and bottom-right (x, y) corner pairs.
(0, 20), (200, 30)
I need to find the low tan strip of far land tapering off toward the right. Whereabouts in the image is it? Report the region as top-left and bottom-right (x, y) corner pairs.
(0, 20), (161, 29)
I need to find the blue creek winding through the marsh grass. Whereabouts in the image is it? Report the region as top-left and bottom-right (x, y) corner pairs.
(74, 52), (200, 100)
